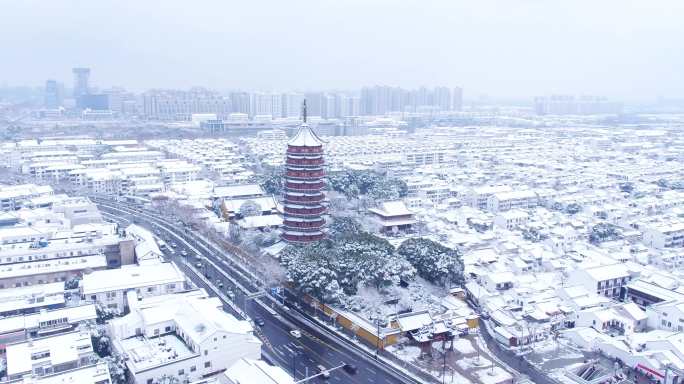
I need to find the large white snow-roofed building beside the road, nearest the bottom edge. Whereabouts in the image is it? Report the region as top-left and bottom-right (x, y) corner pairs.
(109, 292), (261, 384)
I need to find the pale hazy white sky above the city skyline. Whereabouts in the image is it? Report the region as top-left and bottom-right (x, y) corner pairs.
(0, 0), (684, 99)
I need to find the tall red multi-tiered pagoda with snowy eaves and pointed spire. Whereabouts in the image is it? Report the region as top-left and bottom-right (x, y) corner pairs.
(282, 100), (326, 244)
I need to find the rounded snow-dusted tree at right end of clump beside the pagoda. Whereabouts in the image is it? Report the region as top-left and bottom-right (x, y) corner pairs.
(397, 238), (463, 285)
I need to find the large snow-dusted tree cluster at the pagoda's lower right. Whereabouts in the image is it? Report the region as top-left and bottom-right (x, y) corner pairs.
(281, 217), (463, 302)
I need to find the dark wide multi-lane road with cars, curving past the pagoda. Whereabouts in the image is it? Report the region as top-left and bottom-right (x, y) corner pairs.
(94, 199), (419, 384)
